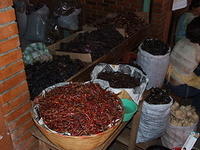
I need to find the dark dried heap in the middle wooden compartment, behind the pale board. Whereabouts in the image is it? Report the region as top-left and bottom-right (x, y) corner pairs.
(58, 27), (123, 60)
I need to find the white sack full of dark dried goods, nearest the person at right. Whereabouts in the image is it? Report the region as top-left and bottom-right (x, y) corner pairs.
(137, 38), (171, 89)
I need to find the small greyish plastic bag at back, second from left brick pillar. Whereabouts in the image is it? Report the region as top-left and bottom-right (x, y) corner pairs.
(58, 9), (81, 30)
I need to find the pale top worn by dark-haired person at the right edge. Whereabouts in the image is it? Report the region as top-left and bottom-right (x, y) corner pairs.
(168, 39), (200, 89)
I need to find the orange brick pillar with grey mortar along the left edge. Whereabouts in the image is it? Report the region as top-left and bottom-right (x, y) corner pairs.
(0, 0), (37, 150)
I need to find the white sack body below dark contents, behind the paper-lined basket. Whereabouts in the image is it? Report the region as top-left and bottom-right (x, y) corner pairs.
(136, 44), (170, 89)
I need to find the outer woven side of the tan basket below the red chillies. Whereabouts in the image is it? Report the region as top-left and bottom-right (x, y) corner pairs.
(33, 117), (120, 150)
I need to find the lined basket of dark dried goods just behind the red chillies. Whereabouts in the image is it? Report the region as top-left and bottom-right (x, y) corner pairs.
(91, 63), (148, 104)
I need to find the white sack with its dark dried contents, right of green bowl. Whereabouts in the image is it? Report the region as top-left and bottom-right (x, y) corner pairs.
(136, 88), (173, 143)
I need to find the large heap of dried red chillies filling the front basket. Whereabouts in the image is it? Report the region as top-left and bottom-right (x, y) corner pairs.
(35, 83), (123, 136)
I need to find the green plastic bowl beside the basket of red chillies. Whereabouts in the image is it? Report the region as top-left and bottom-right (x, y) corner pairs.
(121, 99), (137, 122)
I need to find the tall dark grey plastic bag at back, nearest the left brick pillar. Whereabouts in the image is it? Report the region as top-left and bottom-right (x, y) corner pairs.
(25, 5), (49, 42)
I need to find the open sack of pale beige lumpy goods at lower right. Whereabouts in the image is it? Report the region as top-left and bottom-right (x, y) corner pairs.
(161, 102), (199, 148)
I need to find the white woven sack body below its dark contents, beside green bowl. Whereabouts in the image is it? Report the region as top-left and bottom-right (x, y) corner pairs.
(136, 100), (173, 143)
